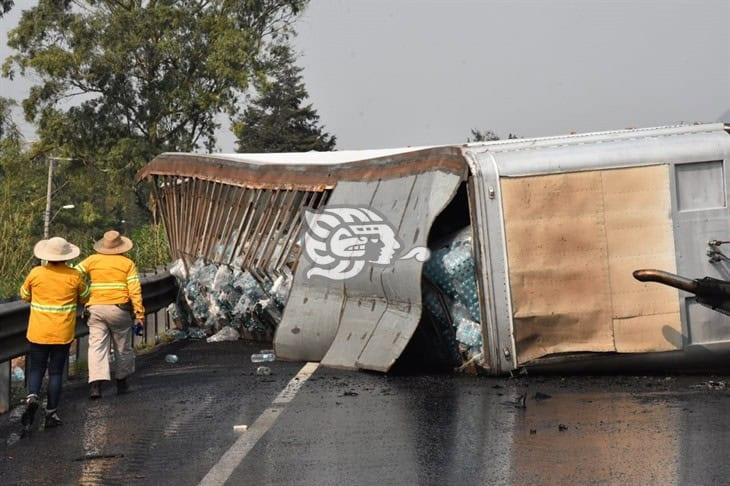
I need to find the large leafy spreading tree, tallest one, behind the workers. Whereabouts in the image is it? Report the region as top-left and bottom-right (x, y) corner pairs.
(3, 0), (307, 226)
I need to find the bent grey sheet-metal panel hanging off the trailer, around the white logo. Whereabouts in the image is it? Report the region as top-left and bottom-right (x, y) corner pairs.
(274, 171), (462, 371)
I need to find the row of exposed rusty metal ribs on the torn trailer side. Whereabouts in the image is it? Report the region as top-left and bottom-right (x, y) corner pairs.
(150, 175), (331, 281)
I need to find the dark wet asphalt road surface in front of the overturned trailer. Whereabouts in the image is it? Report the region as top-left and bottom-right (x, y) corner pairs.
(0, 342), (730, 485)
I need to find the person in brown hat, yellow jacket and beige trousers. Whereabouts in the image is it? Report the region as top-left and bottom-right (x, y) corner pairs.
(76, 231), (145, 399)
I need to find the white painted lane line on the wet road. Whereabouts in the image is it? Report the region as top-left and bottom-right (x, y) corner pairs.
(198, 363), (319, 486)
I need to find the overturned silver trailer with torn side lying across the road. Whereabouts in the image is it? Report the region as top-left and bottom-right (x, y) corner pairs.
(138, 124), (730, 374)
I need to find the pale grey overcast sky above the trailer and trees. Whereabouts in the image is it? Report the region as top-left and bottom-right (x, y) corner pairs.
(0, 0), (730, 151)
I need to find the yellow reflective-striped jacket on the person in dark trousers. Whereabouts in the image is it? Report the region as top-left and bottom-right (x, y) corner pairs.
(20, 263), (89, 344)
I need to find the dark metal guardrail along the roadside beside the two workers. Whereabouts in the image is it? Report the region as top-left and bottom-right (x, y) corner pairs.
(0, 271), (178, 413)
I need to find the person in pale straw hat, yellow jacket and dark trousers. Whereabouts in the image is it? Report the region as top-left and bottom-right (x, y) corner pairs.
(20, 237), (89, 428)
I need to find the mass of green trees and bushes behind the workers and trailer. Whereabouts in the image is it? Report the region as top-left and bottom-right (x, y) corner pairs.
(0, 0), (335, 299)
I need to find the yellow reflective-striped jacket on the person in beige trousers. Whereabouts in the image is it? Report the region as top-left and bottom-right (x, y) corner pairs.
(76, 253), (144, 319)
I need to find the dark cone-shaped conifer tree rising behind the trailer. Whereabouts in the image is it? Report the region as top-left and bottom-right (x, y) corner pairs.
(233, 43), (336, 153)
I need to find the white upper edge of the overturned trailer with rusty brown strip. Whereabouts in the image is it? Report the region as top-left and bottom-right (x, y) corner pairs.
(137, 123), (727, 189)
